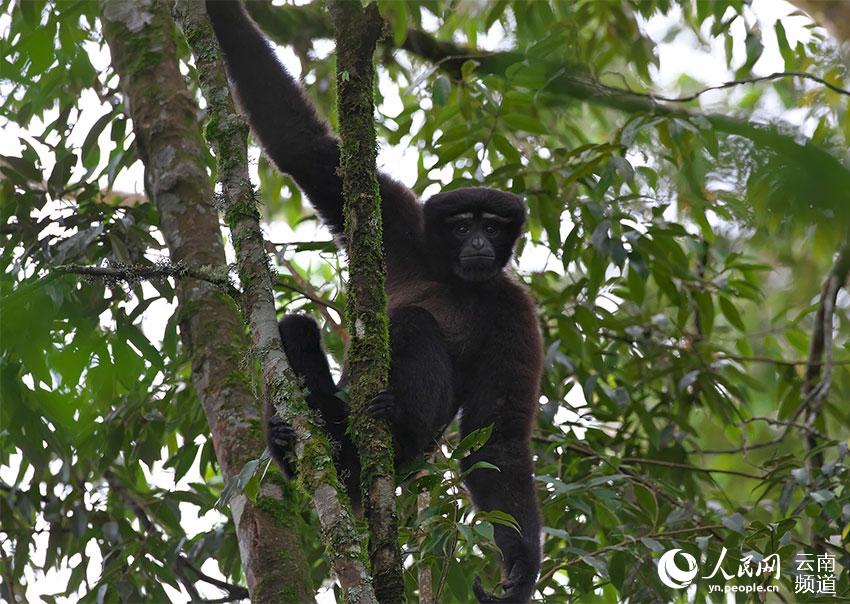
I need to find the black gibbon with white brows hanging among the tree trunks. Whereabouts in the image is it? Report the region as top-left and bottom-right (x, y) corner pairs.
(207, 0), (542, 602)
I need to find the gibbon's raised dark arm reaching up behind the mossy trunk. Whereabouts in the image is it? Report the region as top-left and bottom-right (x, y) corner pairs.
(206, 0), (422, 258)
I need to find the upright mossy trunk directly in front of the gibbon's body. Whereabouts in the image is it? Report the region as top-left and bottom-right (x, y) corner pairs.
(329, 0), (404, 604)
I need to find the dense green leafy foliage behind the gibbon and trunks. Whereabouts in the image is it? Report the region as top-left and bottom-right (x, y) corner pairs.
(0, 0), (850, 602)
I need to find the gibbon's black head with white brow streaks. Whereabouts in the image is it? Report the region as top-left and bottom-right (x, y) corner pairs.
(425, 187), (526, 283)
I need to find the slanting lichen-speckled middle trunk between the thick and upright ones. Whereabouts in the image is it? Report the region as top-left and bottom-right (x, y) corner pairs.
(172, 0), (376, 604)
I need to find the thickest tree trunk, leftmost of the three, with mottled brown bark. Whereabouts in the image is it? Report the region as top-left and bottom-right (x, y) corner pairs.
(101, 0), (314, 603)
